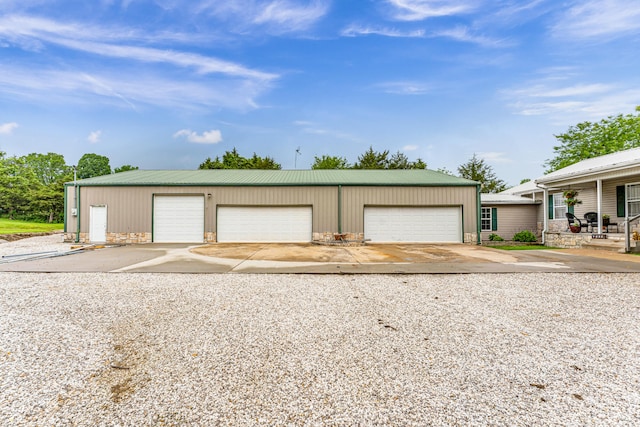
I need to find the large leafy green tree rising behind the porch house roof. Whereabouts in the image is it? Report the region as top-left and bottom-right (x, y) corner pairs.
(545, 106), (640, 173)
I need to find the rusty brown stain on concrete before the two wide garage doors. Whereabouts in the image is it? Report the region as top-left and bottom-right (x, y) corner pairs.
(192, 243), (482, 263)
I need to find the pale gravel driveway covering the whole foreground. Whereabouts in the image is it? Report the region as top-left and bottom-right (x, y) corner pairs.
(0, 273), (640, 426)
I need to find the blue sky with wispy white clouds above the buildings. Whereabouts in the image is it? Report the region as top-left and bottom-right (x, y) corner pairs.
(0, 0), (640, 185)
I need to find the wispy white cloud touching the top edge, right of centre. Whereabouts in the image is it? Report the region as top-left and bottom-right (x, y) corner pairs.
(387, 0), (479, 21)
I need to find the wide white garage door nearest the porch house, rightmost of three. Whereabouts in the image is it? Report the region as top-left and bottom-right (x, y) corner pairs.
(364, 207), (462, 243)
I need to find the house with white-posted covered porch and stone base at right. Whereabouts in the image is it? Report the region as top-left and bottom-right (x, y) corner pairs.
(500, 148), (640, 247)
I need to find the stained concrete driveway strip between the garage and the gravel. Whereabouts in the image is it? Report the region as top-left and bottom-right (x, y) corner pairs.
(0, 244), (640, 274)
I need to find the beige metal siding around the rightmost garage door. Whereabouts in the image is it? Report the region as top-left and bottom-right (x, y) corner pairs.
(342, 187), (477, 237)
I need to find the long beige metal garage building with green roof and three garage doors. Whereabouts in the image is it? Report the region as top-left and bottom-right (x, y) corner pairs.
(65, 169), (480, 243)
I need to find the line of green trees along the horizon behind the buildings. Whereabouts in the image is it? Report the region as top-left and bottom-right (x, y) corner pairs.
(0, 106), (640, 222)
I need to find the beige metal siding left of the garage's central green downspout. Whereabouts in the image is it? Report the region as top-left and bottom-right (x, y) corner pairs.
(75, 186), (338, 233)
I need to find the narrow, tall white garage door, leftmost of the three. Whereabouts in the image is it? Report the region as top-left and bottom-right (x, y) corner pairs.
(153, 196), (204, 243)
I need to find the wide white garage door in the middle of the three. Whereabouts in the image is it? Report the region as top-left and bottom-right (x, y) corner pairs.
(217, 206), (312, 243)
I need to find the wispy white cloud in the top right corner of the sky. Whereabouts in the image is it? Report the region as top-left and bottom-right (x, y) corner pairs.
(552, 0), (640, 41)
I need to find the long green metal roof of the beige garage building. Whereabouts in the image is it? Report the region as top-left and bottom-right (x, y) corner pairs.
(67, 169), (478, 187)
